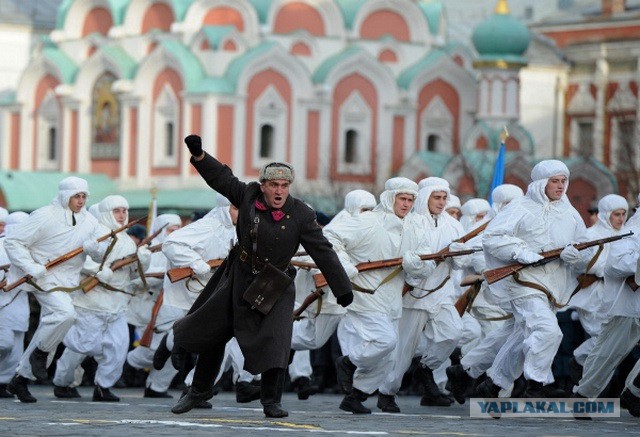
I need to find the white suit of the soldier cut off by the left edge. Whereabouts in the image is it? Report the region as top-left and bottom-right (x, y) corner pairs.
(0, 208), (29, 385)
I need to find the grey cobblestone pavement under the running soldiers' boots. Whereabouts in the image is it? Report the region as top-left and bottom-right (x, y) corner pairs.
(0, 386), (640, 437)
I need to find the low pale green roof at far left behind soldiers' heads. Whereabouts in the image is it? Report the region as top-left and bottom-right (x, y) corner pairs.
(0, 170), (116, 212)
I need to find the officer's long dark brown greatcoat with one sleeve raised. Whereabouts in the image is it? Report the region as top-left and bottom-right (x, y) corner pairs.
(174, 155), (351, 374)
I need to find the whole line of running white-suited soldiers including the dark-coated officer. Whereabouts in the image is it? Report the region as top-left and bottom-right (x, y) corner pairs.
(0, 140), (640, 417)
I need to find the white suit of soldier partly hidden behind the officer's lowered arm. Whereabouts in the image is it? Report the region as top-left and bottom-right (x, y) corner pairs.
(289, 190), (376, 381)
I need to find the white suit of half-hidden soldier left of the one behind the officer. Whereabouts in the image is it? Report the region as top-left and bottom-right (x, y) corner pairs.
(127, 214), (183, 393)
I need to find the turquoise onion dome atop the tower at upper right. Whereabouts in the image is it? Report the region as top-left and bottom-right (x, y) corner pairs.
(471, 7), (531, 59)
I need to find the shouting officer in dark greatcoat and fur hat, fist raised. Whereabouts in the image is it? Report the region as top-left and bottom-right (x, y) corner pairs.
(171, 135), (353, 417)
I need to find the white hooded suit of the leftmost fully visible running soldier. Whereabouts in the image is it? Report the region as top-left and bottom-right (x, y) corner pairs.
(4, 176), (109, 380)
